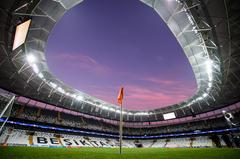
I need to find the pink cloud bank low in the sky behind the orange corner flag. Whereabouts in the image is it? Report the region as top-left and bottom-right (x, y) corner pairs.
(75, 84), (197, 110)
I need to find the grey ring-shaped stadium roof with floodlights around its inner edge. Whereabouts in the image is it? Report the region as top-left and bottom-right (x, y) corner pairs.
(0, 0), (240, 121)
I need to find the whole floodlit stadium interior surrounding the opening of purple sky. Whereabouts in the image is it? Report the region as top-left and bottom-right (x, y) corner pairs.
(0, 0), (240, 159)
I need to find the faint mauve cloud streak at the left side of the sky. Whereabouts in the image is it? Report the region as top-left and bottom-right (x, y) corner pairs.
(49, 53), (111, 73)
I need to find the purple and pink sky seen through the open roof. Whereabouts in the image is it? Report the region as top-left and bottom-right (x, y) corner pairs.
(47, 0), (196, 110)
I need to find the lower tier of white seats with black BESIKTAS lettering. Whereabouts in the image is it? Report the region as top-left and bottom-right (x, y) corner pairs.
(0, 128), (219, 148)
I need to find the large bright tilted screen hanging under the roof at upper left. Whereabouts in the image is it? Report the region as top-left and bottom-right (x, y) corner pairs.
(12, 19), (31, 50)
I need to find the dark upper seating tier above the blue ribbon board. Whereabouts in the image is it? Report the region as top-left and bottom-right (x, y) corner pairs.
(7, 105), (238, 135)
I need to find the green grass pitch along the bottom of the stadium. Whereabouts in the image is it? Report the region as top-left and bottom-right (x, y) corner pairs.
(0, 147), (240, 159)
